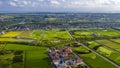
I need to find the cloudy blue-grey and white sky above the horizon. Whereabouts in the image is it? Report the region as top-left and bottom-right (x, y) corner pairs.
(0, 0), (120, 13)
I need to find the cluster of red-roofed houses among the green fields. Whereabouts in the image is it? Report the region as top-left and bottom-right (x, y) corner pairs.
(47, 46), (89, 68)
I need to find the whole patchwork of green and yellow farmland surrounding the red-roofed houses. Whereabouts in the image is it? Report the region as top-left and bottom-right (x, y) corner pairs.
(0, 28), (120, 68)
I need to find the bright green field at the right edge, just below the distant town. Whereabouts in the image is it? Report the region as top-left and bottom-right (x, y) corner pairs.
(90, 29), (120, 37)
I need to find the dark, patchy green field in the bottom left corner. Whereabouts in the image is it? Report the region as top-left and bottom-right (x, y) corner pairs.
(0, 50), (24, 68)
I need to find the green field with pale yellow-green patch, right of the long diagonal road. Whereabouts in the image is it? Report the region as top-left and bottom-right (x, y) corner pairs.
(89, 42), (120, 64)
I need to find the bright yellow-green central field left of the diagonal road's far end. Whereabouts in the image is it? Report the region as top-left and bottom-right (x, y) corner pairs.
(44, 29), (70, 41)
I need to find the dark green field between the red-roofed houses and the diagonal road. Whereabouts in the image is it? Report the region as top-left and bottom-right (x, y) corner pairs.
(73, 46), (116, 68)
